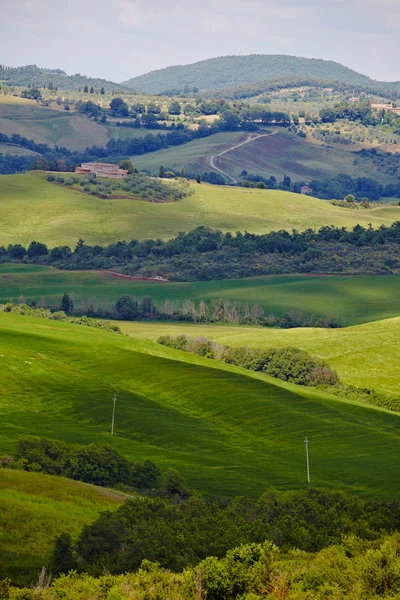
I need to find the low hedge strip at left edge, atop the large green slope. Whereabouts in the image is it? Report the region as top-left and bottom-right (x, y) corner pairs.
(4, 302), (121, 333)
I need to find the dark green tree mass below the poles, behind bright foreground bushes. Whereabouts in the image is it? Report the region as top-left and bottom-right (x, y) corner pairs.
(53, 490), (399, 576)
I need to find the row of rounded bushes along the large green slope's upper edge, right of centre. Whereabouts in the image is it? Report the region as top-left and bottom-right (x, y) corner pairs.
(157, 335), (339, 386)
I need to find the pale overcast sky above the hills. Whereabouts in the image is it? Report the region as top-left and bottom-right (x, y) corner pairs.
(0, 0), (400, 82)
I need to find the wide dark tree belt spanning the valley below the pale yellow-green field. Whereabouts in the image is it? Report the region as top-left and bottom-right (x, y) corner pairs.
(4, 221), (400, 280)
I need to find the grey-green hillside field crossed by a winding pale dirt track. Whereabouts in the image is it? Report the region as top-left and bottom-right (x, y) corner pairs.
(132, 128), (394, 183)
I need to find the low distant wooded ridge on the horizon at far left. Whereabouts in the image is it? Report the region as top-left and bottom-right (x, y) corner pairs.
(0, 65), (124, 92)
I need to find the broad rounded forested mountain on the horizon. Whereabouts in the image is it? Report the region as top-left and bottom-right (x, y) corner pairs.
(122, 54), (400, 94)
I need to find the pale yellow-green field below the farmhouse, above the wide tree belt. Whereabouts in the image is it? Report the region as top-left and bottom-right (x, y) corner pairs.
(0, 172), (400, 246)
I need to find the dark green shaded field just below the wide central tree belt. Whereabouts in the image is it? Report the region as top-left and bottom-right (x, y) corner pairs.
(0, 264), (400, 325)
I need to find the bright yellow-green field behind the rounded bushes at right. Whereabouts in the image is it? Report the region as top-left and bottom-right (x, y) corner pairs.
(119, 317), (400, 397)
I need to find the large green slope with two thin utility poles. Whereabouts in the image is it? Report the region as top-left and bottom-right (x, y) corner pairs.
(0, 313), (400, 496)
